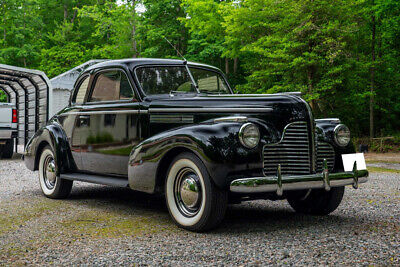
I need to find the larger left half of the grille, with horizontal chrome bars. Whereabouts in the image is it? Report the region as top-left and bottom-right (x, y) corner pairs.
(264, 121), (311, 176)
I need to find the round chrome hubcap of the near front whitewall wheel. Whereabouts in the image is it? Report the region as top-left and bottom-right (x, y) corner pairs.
(174, 168), (202, 217)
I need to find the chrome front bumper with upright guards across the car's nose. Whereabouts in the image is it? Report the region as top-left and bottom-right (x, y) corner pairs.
(230, 160), (368, 196)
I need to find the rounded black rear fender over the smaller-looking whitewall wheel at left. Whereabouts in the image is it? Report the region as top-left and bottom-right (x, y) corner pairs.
(24, 118), (74, 175)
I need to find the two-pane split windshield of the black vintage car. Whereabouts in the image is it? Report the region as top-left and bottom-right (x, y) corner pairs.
(136, 66), (230, 95)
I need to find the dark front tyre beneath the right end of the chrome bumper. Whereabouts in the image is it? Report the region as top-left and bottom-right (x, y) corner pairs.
(287, 186), (344, 215)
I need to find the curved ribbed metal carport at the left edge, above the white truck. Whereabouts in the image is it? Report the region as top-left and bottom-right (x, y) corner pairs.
(0, 64), (52, 150)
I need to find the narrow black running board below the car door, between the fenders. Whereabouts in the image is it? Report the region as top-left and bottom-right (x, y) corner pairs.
(60, 173), (129, 187)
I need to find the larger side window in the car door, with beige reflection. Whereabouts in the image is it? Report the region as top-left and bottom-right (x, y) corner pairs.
(88, 70), (133, 102)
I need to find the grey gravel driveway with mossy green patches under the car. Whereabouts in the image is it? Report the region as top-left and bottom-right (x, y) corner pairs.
(0, 156), (400, 265)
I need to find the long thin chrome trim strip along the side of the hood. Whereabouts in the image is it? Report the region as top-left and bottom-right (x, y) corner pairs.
(149, 107), (273, 113)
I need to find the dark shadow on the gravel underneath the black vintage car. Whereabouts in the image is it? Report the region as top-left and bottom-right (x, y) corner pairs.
(61, 186), (362, 233)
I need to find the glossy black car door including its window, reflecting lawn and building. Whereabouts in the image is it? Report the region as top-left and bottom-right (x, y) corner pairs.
(78, 69), (140, 176)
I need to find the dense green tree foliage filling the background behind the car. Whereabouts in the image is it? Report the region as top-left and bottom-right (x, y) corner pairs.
(0, 0), (400, 136)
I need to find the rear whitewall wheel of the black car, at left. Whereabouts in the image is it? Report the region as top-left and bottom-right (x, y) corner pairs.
(39, 146), (73, 198)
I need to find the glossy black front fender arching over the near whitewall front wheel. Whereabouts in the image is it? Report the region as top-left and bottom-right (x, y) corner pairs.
(128, 122), (262, 193)
